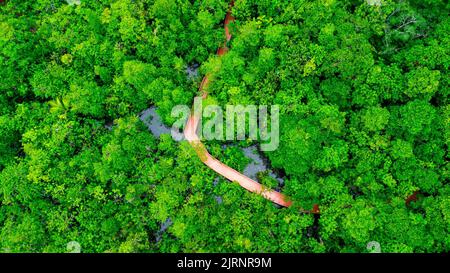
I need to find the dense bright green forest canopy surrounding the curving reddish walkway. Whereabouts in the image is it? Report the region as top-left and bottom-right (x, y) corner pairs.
(0, 0), (450, 252)
